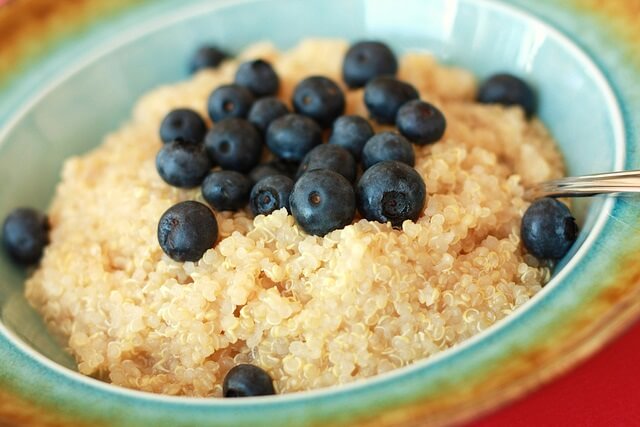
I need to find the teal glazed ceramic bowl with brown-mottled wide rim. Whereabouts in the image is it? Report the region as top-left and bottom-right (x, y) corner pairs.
(0, 0), (640, 427)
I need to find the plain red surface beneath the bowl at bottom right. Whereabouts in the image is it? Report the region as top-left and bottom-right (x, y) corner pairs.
(469, 322), (640, 427)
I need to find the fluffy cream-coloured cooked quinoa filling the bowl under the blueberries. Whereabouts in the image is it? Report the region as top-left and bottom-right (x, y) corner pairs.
(26, 40), (563, 396)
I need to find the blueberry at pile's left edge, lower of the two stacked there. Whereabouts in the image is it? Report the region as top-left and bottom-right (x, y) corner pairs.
(156, 141), (213, 188)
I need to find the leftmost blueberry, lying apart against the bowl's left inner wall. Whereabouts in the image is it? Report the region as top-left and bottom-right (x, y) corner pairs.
(2, 208), (49, 265)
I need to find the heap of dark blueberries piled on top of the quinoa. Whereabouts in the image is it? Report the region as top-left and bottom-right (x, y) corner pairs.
(156, 41), (446, 261)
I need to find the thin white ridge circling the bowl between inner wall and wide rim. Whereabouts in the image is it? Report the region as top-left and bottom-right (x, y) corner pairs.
(0, 0), (627, 422)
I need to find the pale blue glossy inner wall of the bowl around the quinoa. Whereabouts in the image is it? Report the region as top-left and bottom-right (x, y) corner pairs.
(0, 0), (623, 382)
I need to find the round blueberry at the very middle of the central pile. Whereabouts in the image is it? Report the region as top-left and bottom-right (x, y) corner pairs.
(266, 114), (322, 162)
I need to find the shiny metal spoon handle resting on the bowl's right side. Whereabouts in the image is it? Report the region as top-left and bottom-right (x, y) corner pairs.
(525, 170), (640, 200)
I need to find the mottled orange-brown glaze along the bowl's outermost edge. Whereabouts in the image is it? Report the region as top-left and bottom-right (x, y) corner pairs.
(0, 0), (640, 427)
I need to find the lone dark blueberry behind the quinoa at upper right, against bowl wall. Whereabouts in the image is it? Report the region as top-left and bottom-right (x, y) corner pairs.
(477, 73), (537, 117)
